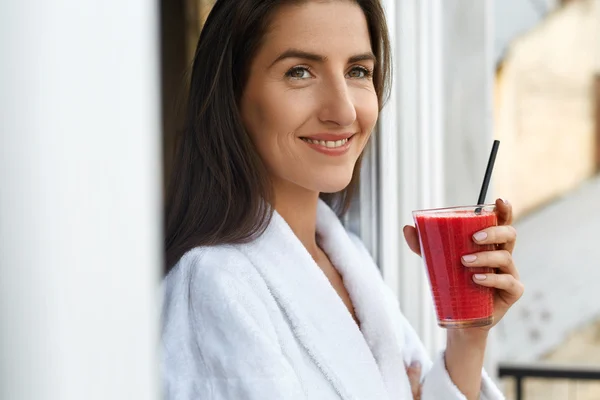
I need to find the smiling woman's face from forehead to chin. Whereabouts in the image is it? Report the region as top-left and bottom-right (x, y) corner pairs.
(241, 1), (379, 194)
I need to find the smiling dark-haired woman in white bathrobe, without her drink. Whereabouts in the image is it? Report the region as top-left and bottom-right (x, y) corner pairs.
(163, 0), (523, 400)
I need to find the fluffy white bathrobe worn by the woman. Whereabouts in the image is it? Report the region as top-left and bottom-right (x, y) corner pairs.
(162, 202), (504, 400)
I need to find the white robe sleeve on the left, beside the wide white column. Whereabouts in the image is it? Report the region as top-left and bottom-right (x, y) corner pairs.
(163, 256), (306, 400)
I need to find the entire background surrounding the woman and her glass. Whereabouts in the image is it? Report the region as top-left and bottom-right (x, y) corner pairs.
(0, 0), (600, 400)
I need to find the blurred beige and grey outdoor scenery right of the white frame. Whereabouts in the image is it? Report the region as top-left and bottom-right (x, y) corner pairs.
(494, 0), (600, 399)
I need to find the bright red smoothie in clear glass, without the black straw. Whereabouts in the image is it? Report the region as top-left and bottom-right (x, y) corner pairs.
(414, 206), (498, 328)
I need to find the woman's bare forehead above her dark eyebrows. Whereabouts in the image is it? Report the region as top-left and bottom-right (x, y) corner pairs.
(263, 0), (371, 57)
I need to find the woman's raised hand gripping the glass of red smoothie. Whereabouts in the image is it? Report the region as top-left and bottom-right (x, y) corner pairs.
(404, 199), (525, 331)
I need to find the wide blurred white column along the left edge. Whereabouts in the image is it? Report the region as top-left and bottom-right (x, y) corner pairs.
(0, 0), (162, 400)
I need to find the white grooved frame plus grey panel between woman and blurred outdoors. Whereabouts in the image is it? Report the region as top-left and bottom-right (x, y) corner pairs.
(379, 0), (493, 360)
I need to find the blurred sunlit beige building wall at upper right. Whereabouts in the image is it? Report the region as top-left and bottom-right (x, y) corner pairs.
(494, 0), (600, 219)
